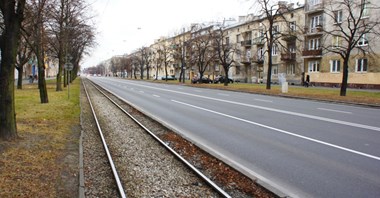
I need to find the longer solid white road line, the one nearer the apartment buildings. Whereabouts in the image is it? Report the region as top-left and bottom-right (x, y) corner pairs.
(113, 79), (380, 131)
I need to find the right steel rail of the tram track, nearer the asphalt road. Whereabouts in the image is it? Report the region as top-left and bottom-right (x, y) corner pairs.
(89, 80), (231, 198)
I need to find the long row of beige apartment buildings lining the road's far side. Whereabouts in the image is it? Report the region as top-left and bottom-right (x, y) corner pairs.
(125, 0), (380, 88)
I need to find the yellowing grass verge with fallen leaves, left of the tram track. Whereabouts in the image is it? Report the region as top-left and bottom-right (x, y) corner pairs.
(0, 79), (80, 197)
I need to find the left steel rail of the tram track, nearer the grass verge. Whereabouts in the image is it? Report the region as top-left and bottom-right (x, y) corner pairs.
(82, 81), (127, 198)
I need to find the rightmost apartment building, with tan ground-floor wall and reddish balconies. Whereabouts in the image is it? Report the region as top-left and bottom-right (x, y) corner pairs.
(302, 0), (380, 88)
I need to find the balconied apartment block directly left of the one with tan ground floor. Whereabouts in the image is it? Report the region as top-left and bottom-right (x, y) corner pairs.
(227, 2), (304, 84)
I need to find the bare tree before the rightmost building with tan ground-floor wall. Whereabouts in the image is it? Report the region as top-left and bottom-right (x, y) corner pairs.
(323, 0), (380, 96)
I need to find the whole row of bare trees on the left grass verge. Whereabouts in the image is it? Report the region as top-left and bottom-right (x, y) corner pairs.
(0, 0), (96, 140)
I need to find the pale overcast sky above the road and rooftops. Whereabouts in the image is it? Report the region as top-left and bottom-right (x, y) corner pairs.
(82, 0), (253, 68)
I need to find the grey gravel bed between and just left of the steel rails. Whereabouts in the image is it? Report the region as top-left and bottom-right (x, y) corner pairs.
(81, 79), (220, 197)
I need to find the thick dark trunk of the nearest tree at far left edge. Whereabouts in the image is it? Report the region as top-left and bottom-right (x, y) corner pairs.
(0, 0), (25, 140)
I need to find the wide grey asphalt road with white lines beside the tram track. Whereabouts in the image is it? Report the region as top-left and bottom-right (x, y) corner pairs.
(91, 77), (380, 198)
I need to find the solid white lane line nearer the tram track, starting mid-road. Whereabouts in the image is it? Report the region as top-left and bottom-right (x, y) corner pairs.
(171, 100), (380, 161)
